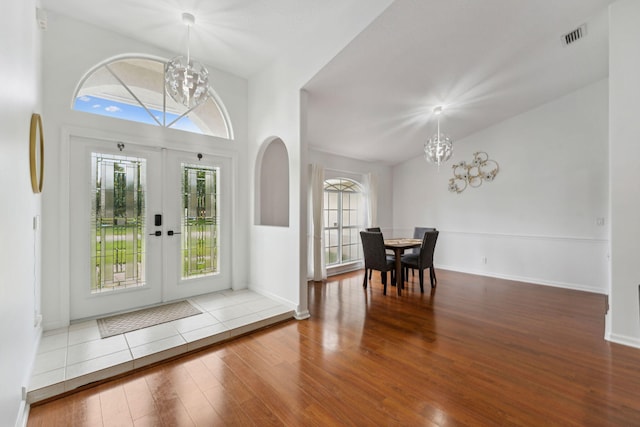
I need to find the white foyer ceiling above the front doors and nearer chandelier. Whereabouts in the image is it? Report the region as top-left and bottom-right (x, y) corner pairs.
(41, 0), (380, 77)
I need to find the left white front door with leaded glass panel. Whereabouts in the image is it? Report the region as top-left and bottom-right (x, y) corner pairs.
(69, 137), (162, 320)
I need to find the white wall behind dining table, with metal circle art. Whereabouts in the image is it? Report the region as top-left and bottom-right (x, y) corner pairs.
(393, 80), (609, 293)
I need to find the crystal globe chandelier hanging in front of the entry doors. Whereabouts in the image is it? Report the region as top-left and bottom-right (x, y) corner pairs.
(164, 13), (209, 109)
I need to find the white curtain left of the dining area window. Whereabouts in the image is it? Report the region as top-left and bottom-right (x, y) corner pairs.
(307, 164), (327, 281)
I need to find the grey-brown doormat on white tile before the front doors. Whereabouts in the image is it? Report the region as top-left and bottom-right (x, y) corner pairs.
(98, 301), (202, 338)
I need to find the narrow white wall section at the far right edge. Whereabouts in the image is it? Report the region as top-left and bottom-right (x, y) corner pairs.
(607, 0), (640, 347)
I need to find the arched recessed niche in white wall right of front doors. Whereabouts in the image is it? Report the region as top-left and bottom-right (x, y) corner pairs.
(255, 137), (289, 227)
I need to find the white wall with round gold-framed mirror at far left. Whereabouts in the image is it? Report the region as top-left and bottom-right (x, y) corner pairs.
(0, 0), (42, 426)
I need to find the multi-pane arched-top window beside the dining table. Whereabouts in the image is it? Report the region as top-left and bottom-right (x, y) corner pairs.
(324, 178), (364, 266)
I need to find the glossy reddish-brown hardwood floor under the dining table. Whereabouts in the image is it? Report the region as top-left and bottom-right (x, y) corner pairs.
(28, 270), (640, 427)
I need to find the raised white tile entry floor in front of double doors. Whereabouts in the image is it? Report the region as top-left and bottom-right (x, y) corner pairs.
(27, 290), (295, 403)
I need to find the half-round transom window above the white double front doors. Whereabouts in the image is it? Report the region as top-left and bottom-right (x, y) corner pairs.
(72, 56), (233, 139)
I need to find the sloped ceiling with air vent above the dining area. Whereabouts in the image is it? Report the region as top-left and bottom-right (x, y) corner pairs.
(306, 0), (611, 164)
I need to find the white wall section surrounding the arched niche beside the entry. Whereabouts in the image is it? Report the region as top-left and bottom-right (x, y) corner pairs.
(249, 0), (391, 318)
